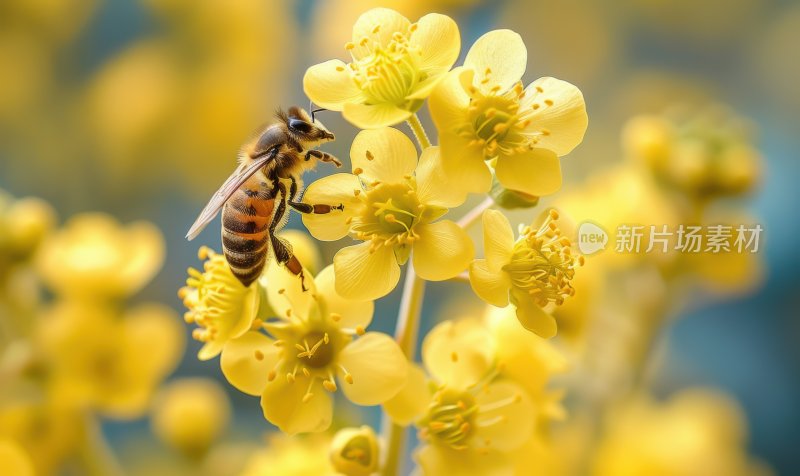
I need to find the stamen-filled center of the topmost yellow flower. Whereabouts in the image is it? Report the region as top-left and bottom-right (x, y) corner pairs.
(345, 25), (427, 106)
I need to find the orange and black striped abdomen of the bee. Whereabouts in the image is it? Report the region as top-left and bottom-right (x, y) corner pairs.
(222, 180), (275, 286)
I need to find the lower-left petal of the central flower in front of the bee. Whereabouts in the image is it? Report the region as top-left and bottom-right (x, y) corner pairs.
(333, 242), (400, 301)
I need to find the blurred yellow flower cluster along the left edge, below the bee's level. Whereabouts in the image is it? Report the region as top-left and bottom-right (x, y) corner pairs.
(0, 192), (184, 474)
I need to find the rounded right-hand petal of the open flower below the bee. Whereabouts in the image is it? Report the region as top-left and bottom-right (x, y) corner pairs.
(339, 332), (408, 405)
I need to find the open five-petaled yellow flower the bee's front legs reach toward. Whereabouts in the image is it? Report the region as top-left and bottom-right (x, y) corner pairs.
(303, 128), (474, 299)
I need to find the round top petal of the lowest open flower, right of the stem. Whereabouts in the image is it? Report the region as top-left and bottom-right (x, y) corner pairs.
(422, 319), (494, 389)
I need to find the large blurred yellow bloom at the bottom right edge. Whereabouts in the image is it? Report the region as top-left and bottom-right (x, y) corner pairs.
(591, 389), (769, 476)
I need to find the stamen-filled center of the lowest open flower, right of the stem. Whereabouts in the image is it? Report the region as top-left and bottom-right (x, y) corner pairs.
(422, 388), (479, 449)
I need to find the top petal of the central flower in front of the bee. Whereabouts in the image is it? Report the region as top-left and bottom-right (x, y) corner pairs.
(350, 127), (417, 183)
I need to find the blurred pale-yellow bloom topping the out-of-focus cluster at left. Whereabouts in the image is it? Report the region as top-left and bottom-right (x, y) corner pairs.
(38, 213), (164, 298)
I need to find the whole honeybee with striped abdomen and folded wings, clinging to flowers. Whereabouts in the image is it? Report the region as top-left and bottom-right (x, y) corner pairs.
(186, 106), (344, 291)
